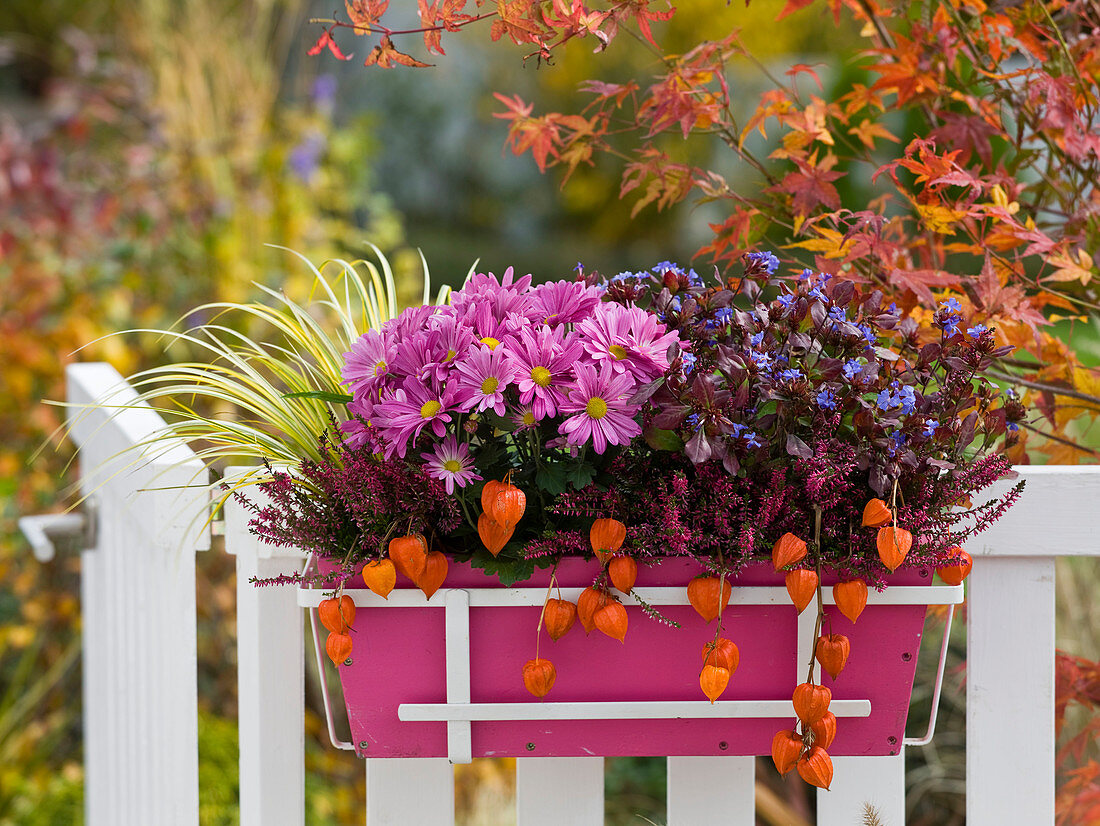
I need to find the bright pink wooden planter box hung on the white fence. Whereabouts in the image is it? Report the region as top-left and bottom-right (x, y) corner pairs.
(300, 559), (938, 762)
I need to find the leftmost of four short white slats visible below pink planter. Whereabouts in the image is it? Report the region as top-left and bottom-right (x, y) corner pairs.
(364, 757), (454, 826)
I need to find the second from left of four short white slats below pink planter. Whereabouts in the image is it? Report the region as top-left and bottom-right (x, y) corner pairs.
(512, 757), (604, 826)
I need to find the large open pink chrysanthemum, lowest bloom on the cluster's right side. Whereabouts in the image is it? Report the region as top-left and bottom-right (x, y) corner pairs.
(558, 362), (641, 453)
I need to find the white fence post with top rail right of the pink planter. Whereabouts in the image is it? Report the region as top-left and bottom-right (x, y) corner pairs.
(966, 465), (1100, 826)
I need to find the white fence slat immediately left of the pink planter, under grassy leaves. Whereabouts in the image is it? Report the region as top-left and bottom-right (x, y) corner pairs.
(226, 467), (306, 826)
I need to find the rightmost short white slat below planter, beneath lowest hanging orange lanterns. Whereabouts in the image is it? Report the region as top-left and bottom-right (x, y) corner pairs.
(817, 748), (902, 826)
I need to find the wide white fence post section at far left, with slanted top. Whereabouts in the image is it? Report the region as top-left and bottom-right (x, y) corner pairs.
(66, 364), (209, 826)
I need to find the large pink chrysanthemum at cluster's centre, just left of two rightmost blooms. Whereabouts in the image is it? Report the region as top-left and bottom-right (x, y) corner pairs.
(508, 327), (584, 419)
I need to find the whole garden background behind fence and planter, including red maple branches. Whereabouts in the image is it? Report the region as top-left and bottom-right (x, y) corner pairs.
(0, 0), (1100, 826)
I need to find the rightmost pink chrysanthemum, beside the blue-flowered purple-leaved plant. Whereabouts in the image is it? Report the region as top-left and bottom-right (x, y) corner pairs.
(576, 302), (680, 384)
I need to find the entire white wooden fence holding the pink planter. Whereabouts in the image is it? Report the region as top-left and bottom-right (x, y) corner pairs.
(30, 364), (1100, 826)
